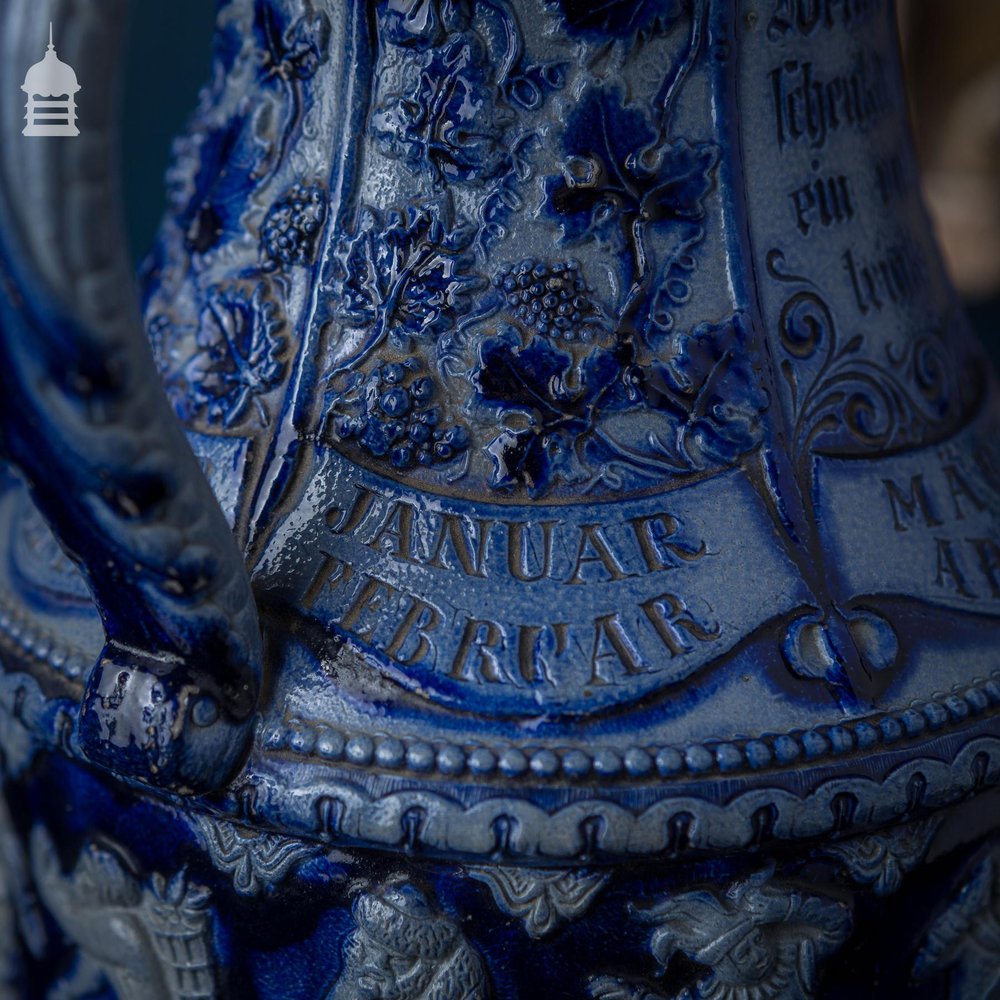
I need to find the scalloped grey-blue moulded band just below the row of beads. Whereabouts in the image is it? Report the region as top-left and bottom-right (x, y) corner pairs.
(240, 720), (1000, 863)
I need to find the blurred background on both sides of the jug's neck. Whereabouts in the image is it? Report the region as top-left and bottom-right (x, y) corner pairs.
(123, 0), (1000, 365)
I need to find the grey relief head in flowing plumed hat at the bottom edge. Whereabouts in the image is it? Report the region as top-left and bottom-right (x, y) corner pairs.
(635, 871), (852, 1000)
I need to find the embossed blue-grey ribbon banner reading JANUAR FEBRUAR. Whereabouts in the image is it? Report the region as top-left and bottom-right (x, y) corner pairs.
(267, 455), (806, 715)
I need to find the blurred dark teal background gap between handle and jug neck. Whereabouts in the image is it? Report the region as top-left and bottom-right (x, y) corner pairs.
(122, 0), (215, 264)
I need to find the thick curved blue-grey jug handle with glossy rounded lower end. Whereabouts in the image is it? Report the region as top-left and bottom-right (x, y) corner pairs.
(0, 0), (262, 792)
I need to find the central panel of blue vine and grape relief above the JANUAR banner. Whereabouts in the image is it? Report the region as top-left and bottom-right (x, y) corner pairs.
(322, 0), (752, 497)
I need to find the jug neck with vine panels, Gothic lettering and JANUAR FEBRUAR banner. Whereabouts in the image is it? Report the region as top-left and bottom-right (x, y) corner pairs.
(150, 0), (989, 718)
